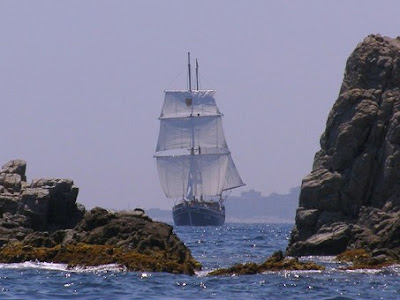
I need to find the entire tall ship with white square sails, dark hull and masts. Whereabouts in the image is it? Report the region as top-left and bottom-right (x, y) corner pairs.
(155, 53), (244, 226)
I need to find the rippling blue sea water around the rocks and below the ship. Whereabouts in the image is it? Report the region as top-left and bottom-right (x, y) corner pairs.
(0, 223), (400, 299)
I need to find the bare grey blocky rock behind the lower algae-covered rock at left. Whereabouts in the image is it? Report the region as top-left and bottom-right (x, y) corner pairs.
(0, 159), (83, 230)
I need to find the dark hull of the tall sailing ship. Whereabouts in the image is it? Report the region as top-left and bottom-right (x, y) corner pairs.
(172, 201), (225, 226)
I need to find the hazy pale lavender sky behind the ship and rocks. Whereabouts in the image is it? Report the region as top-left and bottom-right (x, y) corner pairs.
(0, 0), (400, 209)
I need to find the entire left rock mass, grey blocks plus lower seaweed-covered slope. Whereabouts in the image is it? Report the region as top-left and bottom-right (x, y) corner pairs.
(0, 160), (200, 274)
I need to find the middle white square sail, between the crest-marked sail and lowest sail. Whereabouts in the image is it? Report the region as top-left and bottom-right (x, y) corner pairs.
(156, 116), (227, 152)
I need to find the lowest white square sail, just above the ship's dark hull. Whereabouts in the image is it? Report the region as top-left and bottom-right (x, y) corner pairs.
(157, 154), (229, 198)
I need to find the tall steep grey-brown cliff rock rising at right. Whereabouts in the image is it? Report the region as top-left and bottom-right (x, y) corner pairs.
(287, 35), (400, 259)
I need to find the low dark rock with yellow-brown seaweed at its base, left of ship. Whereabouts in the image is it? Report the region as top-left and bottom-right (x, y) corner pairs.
(0, 208), (200, 274)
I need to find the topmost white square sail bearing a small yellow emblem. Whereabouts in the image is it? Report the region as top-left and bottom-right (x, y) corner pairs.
(160, 90), (221, 119)
